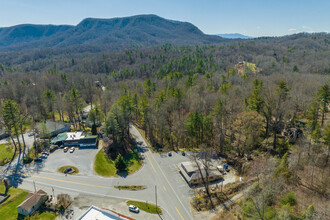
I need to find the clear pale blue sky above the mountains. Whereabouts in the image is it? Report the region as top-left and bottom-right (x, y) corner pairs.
(0, 0), (330, 37)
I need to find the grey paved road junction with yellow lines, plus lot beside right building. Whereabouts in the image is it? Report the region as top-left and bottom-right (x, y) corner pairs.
(0, 127), (194, 220)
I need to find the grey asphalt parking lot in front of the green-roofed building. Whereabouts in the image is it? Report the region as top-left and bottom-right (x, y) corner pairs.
(42, 148), (98, 176)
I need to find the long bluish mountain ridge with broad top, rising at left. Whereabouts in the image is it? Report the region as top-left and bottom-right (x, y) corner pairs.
(0, 15), (226, 51)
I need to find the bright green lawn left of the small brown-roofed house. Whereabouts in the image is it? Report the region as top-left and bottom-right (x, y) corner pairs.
(0, 184), (28, 220)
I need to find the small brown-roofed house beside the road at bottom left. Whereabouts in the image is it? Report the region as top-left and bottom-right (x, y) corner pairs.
(17, 190), (48, 216)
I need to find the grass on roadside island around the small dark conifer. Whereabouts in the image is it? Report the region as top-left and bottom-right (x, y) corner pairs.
(94, 149), (142, 177)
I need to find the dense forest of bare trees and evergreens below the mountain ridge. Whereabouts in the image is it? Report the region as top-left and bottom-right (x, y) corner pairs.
(0, 33), (330, 219)
